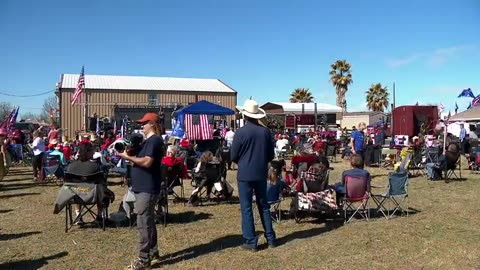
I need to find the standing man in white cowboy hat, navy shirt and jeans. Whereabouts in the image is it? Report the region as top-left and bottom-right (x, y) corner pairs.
(230, 100), (276, 251)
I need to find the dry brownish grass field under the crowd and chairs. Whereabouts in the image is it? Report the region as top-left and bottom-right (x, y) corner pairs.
(0, 158), (480, 270)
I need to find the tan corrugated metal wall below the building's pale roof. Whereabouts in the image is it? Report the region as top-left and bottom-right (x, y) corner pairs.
(60, 89), (237, 138)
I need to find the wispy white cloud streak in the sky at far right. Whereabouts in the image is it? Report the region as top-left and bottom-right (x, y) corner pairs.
(385, 45), (476, 68)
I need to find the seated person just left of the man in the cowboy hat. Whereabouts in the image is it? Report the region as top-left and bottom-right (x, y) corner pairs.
(188, 151), (219, 205)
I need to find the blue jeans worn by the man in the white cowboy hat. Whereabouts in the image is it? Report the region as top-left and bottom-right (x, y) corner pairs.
(238, 180), (276, 247)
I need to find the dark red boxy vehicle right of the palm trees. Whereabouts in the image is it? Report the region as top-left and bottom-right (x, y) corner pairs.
(393, 106), (438, 137)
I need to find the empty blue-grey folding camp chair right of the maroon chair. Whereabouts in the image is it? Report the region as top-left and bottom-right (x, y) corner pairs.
(371, 170), (408, 219)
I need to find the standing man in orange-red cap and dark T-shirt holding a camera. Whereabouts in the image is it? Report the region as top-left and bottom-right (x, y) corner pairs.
(119, 113), (165, 270)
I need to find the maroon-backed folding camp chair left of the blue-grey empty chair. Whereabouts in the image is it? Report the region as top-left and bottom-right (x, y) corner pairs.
(341, 176), (370, 224)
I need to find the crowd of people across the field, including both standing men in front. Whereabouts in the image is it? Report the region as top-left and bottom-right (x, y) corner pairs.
(0, 100), (478, 269)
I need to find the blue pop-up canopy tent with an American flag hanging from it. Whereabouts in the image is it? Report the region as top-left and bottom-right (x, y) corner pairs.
(172, 100), (235, 140)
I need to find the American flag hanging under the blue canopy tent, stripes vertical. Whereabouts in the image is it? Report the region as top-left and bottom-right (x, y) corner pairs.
(185, 114), (213, 140)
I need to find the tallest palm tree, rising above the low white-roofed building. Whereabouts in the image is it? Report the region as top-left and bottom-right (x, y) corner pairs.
(330, 60), (353, 112)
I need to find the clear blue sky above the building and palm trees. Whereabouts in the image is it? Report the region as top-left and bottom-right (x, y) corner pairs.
(0, 0), (480, 113)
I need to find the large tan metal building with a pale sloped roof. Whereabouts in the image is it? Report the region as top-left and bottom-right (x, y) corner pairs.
(56, 74), (237, 138)
